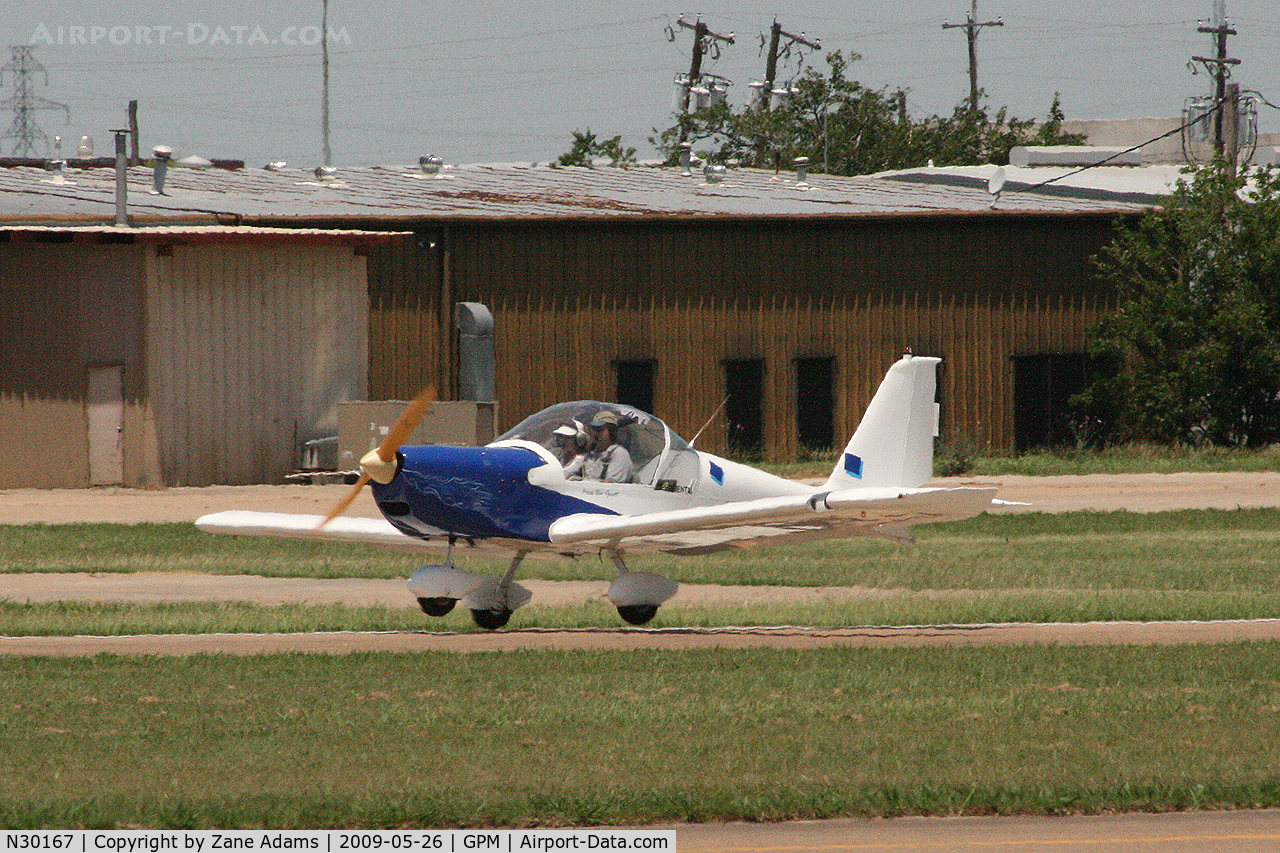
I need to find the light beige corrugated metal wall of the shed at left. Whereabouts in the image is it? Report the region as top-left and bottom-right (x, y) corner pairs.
(147, 245), (369, 485)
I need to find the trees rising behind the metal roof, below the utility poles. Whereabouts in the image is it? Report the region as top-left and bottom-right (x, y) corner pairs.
(650, 50), (1083, 174)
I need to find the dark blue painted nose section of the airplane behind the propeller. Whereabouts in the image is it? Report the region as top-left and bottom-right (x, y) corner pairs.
(372, 444), (617, 542)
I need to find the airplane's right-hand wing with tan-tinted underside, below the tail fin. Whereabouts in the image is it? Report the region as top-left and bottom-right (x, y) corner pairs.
(549, 487), (996, 553)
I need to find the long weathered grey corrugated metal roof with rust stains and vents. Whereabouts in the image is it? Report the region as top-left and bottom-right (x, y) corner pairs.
(0, 156), (1152, 222)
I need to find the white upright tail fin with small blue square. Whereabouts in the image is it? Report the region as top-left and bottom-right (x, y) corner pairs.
(827, 353), (942, 489)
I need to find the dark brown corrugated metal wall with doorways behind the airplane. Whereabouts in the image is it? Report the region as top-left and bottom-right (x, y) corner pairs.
(370, 214), (1112, 459)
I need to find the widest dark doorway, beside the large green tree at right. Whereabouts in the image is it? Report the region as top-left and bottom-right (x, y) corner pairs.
(1014, 352), (1097, 453)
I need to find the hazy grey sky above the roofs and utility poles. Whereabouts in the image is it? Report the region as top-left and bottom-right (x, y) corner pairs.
(0, 0), (1280, 167)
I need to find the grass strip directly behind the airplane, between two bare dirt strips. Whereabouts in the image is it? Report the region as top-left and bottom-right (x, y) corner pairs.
(0, 508), (1280, 593)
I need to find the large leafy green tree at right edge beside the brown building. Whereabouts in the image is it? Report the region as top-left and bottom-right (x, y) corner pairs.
(1076, 161), (1280, 447)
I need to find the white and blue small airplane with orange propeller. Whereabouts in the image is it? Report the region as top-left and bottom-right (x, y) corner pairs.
(196, 351), (1006, 630)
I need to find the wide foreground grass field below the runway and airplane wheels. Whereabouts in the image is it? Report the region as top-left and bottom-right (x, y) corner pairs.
(0, 643), (1280, 827)
